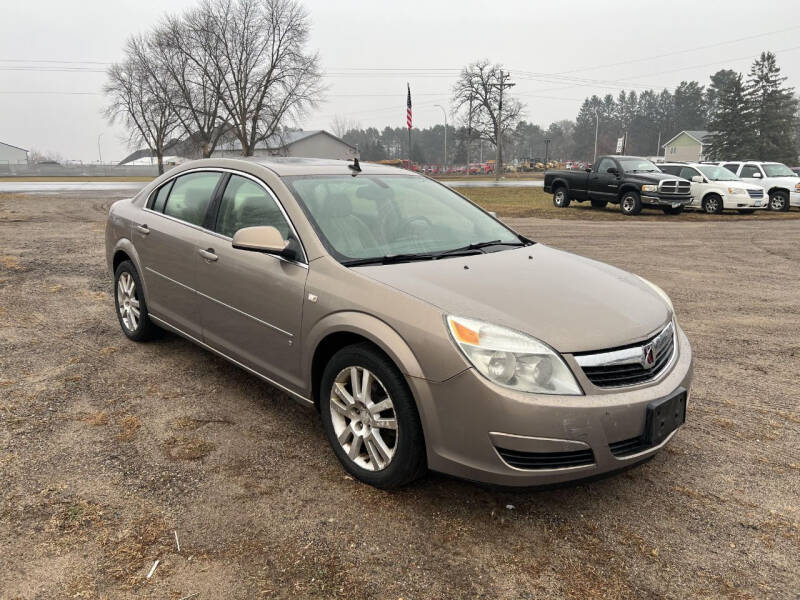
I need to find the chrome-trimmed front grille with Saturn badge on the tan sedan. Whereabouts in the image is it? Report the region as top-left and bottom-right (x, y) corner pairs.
(575, 323), (675, 388)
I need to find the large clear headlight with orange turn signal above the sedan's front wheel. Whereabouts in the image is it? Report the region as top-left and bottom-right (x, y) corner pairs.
(447, 316), (583, 396)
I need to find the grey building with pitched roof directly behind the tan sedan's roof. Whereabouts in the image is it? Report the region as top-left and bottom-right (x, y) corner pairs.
(212, 129), (358, 160)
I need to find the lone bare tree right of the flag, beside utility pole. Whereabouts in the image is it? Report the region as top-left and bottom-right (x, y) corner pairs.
(452, 60), (523, 176)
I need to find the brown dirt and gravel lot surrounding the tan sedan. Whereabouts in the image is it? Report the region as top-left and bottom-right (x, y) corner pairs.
(0, 193), (800, 600)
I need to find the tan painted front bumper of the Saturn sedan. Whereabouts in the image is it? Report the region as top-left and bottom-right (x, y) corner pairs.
(410, 328), (692, 486)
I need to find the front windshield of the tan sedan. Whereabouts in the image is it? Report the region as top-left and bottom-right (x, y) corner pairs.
(284, 175), (528, 264)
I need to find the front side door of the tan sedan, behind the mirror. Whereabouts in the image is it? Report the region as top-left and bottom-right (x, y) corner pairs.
(195, 175), (308, 388)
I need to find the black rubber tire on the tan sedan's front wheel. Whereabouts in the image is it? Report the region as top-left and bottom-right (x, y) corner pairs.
(319, 343), (428, 489)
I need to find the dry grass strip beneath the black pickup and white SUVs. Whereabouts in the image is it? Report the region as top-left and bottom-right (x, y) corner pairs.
(455, 188), (800, 222)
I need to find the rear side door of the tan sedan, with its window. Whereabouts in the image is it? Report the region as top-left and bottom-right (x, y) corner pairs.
(133, 171), (222, 339)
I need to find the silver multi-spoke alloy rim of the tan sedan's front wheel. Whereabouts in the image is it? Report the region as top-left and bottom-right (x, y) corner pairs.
(329, 366), (399, 471)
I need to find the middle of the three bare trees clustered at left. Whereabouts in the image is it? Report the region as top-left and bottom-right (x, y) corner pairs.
(143, 10), (225, 158)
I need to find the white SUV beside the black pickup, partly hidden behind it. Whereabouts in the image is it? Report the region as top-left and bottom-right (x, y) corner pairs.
(658, 162), (767, 214)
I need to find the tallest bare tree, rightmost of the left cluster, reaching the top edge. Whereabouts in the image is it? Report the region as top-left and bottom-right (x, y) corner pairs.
(198, 0), (322, 156)
